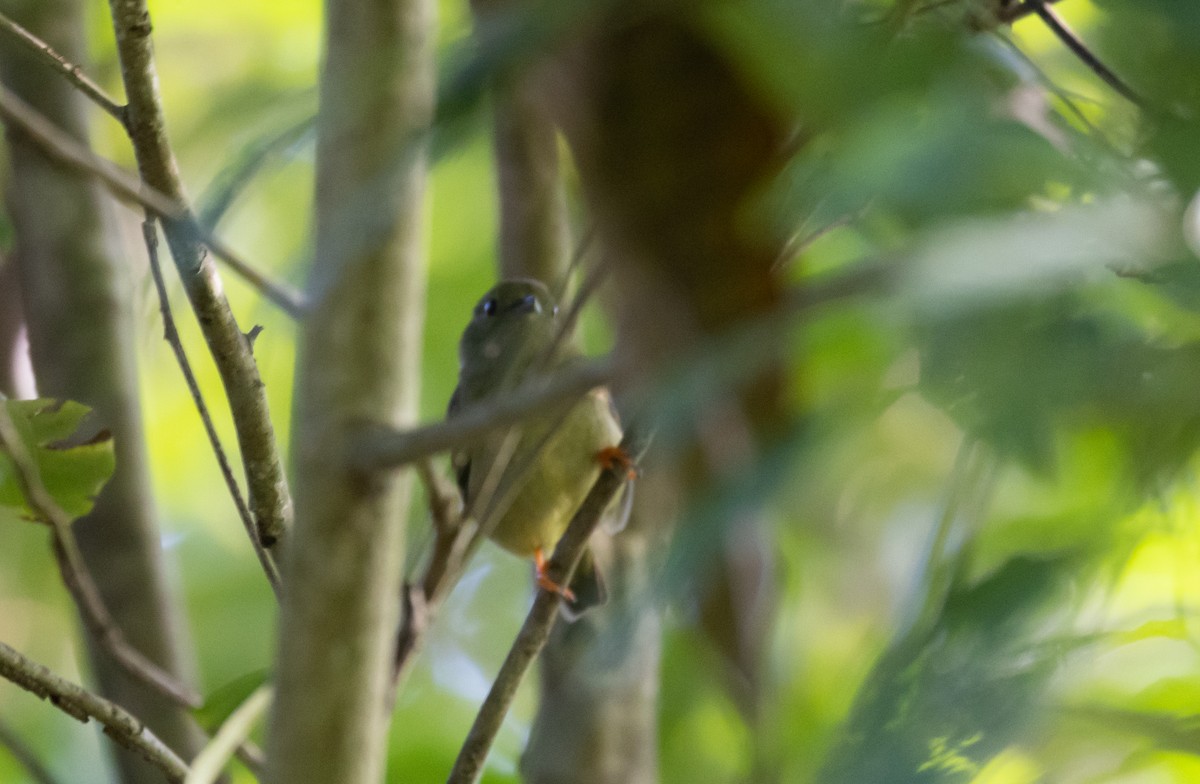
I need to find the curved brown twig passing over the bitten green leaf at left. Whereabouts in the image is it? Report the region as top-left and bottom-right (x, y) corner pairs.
(0, 395), (203, 708)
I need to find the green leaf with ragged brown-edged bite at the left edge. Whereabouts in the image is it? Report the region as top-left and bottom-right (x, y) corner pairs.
(0, 399), (116, 517)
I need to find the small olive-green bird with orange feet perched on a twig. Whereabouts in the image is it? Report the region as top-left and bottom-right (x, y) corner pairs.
(448, 280), (631, 615)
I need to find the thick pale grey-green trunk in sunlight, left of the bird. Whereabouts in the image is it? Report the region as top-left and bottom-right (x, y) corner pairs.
(268, 0), (434, 784)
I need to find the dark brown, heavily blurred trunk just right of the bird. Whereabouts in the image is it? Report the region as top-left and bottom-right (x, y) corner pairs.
(546, 5), (791, 763)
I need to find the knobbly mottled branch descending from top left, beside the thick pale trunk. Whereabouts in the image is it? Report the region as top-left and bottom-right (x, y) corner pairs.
(108, 0), (292, 547)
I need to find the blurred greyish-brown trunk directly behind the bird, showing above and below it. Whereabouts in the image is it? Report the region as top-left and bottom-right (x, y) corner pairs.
(463, 7), (660, 784)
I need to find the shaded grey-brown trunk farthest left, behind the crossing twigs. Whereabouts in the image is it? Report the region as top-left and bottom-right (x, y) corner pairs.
(0, 0), (199, 784)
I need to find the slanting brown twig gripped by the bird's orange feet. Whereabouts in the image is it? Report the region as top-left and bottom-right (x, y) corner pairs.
(446, 431), (635, 784)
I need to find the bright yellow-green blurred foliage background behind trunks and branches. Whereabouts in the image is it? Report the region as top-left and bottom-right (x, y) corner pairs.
(7, 0), (1200, 784)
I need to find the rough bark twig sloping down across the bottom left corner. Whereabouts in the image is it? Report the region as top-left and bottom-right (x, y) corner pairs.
(0, 642), (187, 782)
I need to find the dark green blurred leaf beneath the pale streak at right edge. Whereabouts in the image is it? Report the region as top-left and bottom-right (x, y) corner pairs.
(920, 289), (1200, 477)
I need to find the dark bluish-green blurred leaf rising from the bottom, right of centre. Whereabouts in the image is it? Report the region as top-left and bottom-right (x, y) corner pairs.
(820, 557), (1073, 784)
